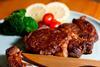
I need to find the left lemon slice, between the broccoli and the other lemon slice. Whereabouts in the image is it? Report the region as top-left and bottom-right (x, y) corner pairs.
(26, 3), (46, 22)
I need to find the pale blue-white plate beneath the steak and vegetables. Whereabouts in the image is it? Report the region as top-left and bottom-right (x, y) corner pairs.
(0, 11), (100, 67)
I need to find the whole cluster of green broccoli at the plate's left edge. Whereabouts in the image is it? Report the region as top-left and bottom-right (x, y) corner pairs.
(0, 9), (38, 35)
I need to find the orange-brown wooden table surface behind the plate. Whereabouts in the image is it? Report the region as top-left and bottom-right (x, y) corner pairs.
(0, 0), (100, 20)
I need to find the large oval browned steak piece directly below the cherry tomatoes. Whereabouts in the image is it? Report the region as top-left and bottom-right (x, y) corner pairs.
(25, 29), (69, 57)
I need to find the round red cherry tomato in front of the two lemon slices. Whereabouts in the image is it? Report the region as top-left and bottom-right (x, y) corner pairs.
(43, 13), (54, 25)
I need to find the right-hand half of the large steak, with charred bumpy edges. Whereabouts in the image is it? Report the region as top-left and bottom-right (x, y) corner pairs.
(57, 16), (98, 57)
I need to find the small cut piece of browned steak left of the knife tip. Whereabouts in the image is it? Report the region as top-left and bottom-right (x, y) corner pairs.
(6, 46), (26, 67)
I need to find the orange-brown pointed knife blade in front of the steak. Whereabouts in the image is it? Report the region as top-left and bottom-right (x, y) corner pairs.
(23, 53), (100, 67)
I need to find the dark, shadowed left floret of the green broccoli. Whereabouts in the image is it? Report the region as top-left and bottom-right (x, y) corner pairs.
(2, 14), (25, 35)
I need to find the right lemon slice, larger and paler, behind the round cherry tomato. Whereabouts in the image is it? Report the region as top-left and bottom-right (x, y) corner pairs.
(46, 2), (70, 23)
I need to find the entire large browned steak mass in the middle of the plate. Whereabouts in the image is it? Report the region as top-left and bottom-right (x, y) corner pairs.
(25, 16), (98, 57)
